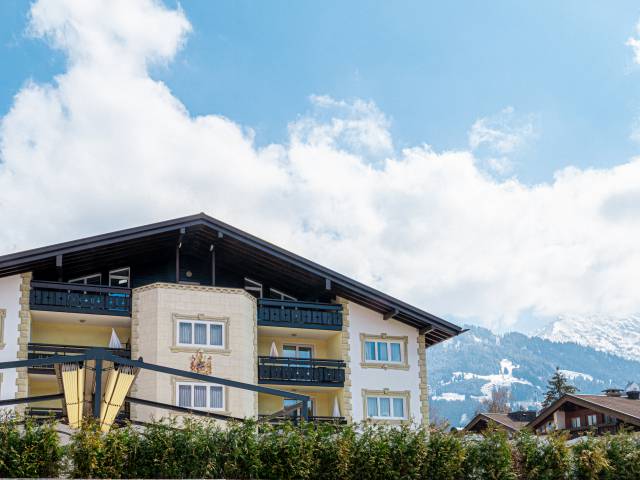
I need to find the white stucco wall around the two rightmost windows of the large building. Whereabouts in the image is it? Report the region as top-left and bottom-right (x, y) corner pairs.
(349, 302), (422, 423)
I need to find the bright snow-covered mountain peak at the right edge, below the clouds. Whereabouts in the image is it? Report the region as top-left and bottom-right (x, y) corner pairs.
(536, 315), (640, 361)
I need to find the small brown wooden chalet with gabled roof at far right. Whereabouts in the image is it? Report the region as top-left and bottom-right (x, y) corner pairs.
(528, 385), (640, 437)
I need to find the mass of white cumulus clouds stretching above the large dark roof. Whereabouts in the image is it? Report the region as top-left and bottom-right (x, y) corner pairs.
(0, 0), (640, 326)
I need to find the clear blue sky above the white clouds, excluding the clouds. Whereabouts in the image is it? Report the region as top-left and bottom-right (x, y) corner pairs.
(0, 0), (640, 183)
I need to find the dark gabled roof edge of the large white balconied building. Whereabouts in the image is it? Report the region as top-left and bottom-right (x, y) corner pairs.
(0, 213), (465, 345)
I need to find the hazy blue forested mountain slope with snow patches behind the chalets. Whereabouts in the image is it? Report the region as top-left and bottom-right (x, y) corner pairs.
(427, 326), (640, 427)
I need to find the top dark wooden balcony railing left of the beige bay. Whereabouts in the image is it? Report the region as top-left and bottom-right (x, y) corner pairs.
(29, 281), (131, 317)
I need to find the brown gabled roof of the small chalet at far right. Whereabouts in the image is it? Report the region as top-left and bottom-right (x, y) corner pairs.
(528, 394), (640, 429)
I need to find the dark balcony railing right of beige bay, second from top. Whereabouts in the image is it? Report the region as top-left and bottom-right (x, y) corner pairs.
(258, 357), (346, 387)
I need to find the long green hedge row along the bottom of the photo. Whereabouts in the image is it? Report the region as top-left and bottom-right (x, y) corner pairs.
(0, 419), (640, 480)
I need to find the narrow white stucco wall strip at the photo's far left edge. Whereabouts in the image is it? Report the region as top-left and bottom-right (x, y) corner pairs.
(0, 275), (22, 400)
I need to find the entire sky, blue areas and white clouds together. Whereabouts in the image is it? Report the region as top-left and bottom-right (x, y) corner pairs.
(0, 0), (640, 331)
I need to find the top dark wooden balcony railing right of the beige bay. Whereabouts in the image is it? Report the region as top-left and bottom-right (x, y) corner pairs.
(258, 298), (342, 330)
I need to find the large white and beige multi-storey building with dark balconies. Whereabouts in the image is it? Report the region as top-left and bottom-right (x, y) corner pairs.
(0, 214), (462, 423)
